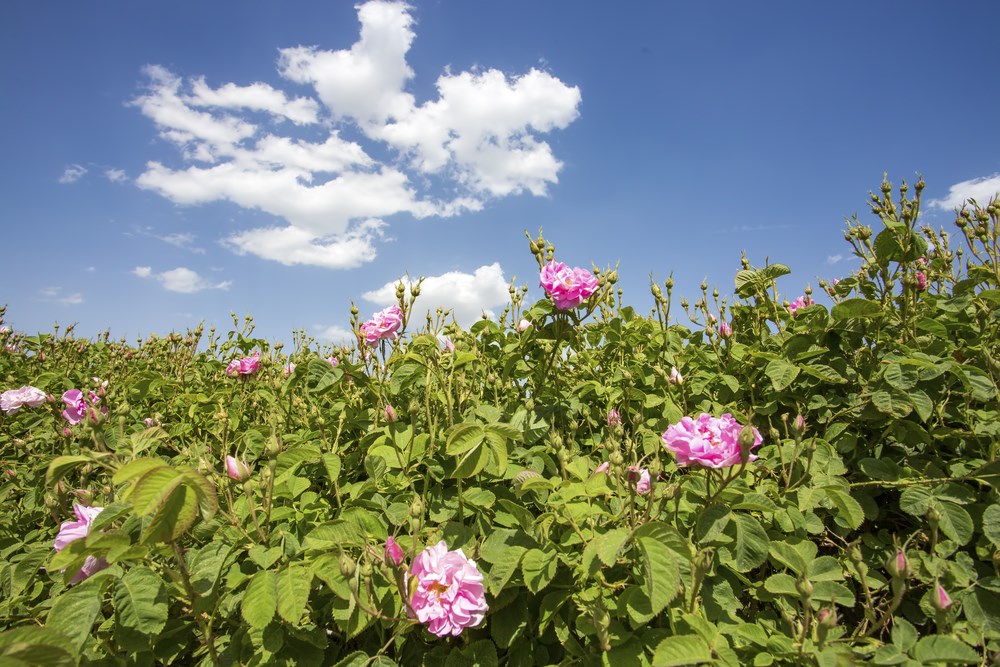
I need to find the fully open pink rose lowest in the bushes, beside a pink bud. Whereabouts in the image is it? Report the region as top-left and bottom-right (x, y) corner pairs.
(408, 540), (489, 637)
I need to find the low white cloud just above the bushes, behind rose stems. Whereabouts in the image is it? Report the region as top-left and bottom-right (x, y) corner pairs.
(362, 263), (510, 327)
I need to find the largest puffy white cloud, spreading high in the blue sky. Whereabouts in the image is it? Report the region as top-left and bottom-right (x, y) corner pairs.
(132, 0), (581, 268)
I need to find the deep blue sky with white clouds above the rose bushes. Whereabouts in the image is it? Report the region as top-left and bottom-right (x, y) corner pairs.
(0, 0), (1000, 350)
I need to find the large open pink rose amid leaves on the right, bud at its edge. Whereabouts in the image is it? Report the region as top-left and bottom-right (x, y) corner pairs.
(663, 412), (764, 468)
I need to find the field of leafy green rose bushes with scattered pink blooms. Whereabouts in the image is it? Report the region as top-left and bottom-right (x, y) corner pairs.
(0, 180), (1000, 667)
